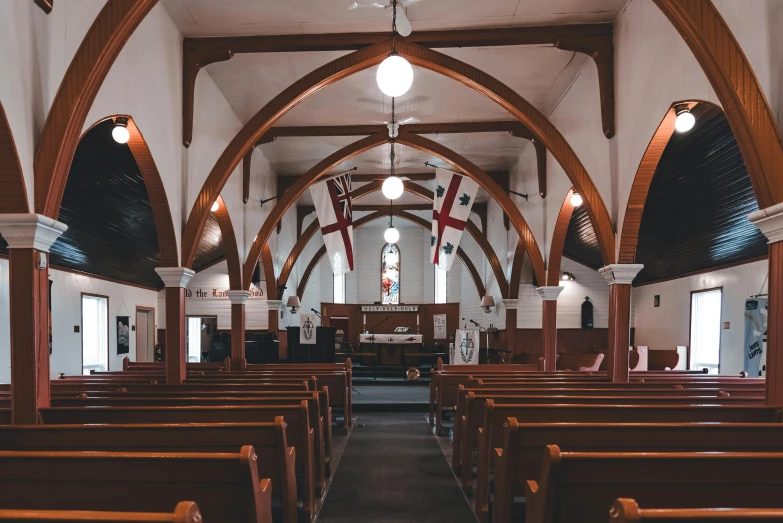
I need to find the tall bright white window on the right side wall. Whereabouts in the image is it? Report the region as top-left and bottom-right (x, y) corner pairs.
(689, 288), (723, 374)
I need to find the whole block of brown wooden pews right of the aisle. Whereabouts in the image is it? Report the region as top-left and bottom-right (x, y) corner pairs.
(431, 365), (783, 523)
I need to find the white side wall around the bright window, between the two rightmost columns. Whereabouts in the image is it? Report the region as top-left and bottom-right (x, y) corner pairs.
(633, 261), (767, 374)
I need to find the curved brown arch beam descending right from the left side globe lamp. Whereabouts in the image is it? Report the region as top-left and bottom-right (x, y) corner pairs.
(126, 116), (179, 267)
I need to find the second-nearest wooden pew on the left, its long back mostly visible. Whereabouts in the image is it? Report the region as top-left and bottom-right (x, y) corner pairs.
(0, 445), (272, 523)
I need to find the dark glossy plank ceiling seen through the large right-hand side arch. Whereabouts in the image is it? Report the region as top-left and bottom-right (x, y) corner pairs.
(634, 104), (767, 283)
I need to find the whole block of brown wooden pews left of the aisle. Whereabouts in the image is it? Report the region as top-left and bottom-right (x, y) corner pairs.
(0, 361), (351, 523)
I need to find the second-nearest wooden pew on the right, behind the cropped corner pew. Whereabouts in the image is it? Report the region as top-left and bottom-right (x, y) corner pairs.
(525, 445), (783, 523)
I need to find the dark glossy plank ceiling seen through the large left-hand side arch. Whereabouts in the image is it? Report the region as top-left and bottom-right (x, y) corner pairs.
(51, 120), (163, 288)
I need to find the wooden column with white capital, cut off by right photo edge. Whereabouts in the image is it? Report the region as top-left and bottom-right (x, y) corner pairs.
(748, 203), (783, 405)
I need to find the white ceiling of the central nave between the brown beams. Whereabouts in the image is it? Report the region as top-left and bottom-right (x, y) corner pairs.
(161, 0), (628, 207)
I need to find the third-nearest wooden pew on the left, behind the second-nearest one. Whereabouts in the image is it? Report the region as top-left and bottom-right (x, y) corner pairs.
(0, 416), (298, 523)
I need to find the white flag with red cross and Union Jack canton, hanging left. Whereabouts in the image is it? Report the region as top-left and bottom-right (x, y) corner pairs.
(310, 173), (353, 276)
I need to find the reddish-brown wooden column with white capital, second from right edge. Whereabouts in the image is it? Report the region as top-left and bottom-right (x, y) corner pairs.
(598, 264), (644, 383)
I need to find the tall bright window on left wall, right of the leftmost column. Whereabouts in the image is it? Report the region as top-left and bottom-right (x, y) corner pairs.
(82, 294), (109, 374)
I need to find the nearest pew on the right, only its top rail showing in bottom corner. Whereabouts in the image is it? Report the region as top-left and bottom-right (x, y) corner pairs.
(609, 500), (783, 523)
